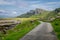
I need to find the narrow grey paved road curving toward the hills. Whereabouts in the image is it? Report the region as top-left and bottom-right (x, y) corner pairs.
(20, 22), (57, 40)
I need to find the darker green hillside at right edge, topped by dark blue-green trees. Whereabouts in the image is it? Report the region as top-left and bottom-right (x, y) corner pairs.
(46, 8), (60, 20)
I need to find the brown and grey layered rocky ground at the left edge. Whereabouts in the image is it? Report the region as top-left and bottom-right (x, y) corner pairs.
(0, 20), (20, 34)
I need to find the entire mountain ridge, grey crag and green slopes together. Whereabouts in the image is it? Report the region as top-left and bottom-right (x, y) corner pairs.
(18, 8), (60, 21)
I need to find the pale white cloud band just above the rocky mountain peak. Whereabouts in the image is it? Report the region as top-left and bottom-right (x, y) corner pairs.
(29, 4), (52, 10)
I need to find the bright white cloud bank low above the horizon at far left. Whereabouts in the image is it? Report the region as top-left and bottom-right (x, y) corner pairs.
(0, 10), (19, 17)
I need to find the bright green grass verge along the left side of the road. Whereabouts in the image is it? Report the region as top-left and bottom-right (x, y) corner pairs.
(3, 21), (39, 40)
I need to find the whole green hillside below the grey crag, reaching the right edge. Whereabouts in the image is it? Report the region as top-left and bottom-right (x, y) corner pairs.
(30, 8), (60, 21)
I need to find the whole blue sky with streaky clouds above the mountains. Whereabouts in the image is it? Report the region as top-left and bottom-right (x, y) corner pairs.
(0, 0), (60, 17)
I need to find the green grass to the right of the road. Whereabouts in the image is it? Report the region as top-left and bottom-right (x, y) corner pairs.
(52, 19), (60, 40)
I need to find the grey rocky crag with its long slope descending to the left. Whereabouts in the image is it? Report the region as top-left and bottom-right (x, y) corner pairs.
(17, 8), (46, 18)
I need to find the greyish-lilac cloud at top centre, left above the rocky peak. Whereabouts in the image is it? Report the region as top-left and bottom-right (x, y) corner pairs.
(16, 0), (40, 8)
